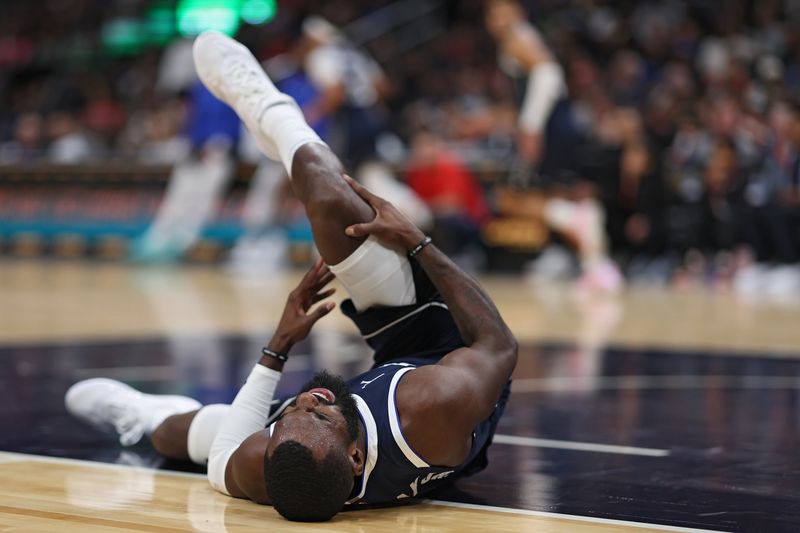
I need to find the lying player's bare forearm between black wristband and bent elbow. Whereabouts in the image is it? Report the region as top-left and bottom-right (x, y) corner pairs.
(416, 245), (515, 353)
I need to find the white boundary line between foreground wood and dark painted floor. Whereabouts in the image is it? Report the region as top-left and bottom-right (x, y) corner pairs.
(0, 450), (719, 533)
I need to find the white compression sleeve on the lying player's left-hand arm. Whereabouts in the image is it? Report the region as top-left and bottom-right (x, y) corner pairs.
(208, 365), (281, 494)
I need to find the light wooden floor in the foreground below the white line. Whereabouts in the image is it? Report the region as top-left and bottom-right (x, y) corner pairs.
(0, 452), (700, 533)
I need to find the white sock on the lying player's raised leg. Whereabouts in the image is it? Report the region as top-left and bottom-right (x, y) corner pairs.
(259, 102), (327, 178)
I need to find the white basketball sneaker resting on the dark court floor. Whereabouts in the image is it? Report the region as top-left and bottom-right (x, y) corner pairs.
(64, 378), (202, 446)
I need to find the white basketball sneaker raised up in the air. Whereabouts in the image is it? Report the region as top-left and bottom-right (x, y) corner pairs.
(192, 31), (290, 161)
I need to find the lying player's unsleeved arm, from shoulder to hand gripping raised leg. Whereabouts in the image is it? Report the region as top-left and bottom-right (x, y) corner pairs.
(347, 178), (517, 465)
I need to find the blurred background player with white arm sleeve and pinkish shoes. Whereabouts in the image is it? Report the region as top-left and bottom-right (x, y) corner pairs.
(486, 0), (622, 291)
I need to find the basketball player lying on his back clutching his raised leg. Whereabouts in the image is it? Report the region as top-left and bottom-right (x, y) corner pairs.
(66, 32), (517, 521)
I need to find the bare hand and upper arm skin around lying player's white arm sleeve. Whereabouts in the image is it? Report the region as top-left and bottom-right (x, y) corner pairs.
(225, 259), (336, 505)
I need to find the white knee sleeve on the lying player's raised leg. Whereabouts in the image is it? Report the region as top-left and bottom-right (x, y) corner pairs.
(330, 237), (417, 311)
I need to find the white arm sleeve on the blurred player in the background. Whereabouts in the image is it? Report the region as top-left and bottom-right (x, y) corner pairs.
(519, 62), (566, 133)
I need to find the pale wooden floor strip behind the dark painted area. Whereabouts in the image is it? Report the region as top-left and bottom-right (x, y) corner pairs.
(0, 260), (800, 355)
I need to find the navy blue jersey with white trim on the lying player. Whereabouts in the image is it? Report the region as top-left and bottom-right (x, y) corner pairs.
(269, 358), (508, 504)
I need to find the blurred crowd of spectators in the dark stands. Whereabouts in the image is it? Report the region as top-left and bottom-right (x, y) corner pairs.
(0, 0), (800, 293)
